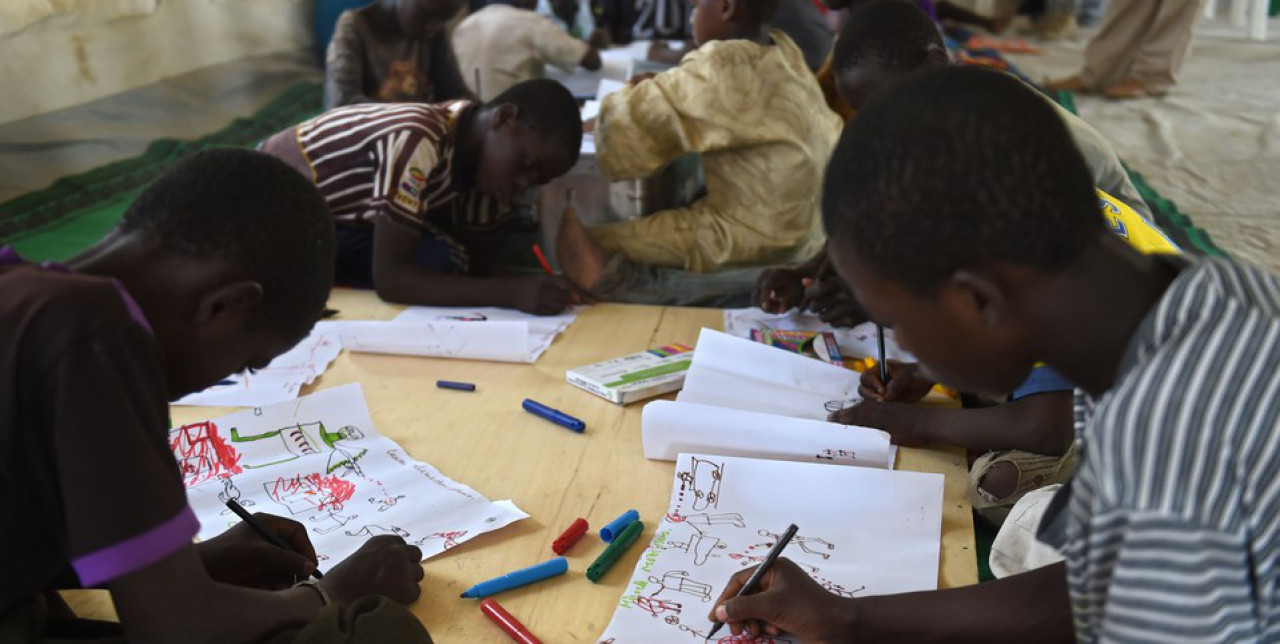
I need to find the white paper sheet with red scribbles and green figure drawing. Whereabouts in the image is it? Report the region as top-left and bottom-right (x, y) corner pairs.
(169, 384), (529, 567)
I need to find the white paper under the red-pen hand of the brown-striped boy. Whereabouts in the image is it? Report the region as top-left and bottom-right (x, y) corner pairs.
(317, 306), (577, 362)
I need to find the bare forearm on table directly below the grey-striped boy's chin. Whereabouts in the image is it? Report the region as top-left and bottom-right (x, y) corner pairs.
(910, 392), (1073, 456)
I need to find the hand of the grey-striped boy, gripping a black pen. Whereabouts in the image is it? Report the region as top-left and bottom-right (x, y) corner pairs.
(710, 557), (855, 644)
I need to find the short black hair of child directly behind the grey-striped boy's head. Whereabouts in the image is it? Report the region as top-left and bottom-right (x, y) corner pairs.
(832, 0), (946, 74)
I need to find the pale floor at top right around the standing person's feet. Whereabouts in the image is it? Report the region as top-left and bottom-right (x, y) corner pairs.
(1010, 15), (1280, 270)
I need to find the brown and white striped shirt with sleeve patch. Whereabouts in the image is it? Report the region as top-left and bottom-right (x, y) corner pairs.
(293, 101), (507, 236)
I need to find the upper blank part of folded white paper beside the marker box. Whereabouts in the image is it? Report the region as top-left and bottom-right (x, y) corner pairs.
(676, 329), (861, 420)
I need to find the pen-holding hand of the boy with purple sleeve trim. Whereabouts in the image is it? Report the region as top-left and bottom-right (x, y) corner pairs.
(196, 512), (316, 590)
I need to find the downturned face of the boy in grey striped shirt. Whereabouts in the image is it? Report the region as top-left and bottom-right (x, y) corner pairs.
(828, 241), (1034, 394)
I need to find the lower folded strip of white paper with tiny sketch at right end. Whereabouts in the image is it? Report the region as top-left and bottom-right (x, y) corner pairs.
(640, 401), (897, 470)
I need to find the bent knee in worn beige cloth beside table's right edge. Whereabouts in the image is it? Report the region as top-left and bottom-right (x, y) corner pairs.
(966, 444), (1079, 526)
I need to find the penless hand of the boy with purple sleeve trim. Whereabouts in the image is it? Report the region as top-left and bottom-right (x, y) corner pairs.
(320, 534), (425, 604)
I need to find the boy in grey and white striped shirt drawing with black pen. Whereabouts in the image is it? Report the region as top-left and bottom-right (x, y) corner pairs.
(712, 68), (1280, 643)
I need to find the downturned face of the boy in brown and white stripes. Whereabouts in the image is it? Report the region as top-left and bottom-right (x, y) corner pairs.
(475, 120), (570, 201)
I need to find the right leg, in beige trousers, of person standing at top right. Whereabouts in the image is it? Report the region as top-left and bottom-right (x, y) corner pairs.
(1133, 0), (1203, 96)
